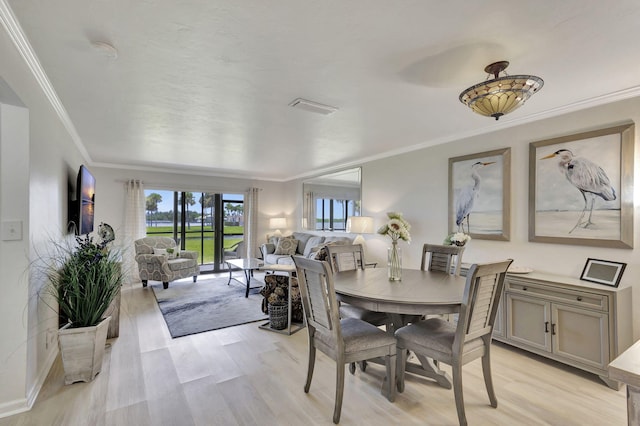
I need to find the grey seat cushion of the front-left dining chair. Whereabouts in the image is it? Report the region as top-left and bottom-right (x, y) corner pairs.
(316, 318), (396, 354)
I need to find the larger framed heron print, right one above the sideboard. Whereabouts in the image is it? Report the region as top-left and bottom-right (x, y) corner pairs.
(529, 124), (634, 248)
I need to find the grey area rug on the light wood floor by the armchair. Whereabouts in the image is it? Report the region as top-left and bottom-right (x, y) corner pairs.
(149, 276), (267, 338)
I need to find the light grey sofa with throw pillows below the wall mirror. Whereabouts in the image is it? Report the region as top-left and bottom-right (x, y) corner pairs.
(260, 232), (353, 265)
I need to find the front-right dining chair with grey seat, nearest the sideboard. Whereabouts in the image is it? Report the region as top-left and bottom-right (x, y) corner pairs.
(395, 259), (513, 425)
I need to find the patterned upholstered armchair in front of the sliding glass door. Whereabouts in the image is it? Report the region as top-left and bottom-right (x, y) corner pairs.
(134, 237), (200, 288)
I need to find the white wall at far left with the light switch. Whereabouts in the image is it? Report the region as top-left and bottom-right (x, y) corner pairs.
(0, 26), (83, 417)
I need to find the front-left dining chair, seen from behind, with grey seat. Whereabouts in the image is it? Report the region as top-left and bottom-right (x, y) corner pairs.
(293, 256), (396, 423)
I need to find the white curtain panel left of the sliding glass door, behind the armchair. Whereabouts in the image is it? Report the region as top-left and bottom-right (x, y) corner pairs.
(122, 179), (147, 283)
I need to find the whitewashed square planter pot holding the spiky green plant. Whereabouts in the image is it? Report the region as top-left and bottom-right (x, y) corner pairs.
(58, 317), (111, 385)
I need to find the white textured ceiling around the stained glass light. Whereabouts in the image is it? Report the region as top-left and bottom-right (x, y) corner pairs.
(0, 0), (640, 180)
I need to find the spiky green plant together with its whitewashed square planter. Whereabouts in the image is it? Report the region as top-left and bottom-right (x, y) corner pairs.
(47, 224), (122, 384)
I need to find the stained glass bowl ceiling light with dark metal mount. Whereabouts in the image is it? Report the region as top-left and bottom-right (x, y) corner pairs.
(459, 61), (544, 120)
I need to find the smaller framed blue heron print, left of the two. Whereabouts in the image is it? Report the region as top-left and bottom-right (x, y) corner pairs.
(449, 148), (511, 241)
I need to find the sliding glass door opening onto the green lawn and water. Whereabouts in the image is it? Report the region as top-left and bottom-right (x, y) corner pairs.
(145, 189), (244, 273)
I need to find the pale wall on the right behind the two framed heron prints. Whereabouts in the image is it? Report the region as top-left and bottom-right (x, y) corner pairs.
(340, 98), (640, 339)
